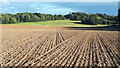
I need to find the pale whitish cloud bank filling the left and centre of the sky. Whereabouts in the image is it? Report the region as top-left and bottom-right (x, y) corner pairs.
(2, 2), (78, 14)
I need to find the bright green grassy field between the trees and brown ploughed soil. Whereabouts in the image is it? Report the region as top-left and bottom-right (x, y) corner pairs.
(4, 20), (106, 27)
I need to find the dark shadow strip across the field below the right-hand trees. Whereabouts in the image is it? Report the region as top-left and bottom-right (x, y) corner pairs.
(65, 26), (120, 31)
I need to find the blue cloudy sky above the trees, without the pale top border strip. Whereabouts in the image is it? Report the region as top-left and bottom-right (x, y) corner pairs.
(0, 2), (118, 15)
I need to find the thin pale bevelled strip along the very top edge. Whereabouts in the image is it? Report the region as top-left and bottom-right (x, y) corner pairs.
(0, 0), (119, 2)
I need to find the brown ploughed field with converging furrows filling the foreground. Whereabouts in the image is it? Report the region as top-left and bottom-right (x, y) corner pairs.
(0, 25), (120, 66)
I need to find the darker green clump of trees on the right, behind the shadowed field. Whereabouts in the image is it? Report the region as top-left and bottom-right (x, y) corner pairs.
(65, 12), (117, 25)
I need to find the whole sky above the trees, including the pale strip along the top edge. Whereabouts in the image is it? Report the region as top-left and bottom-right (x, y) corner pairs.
(0, 0), (120, 15)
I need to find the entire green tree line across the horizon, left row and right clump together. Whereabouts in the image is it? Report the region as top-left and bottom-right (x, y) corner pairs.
(0, 10), (120, 25)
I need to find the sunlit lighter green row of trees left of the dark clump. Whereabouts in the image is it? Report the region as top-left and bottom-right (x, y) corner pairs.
(1, 13), (65, 24)
